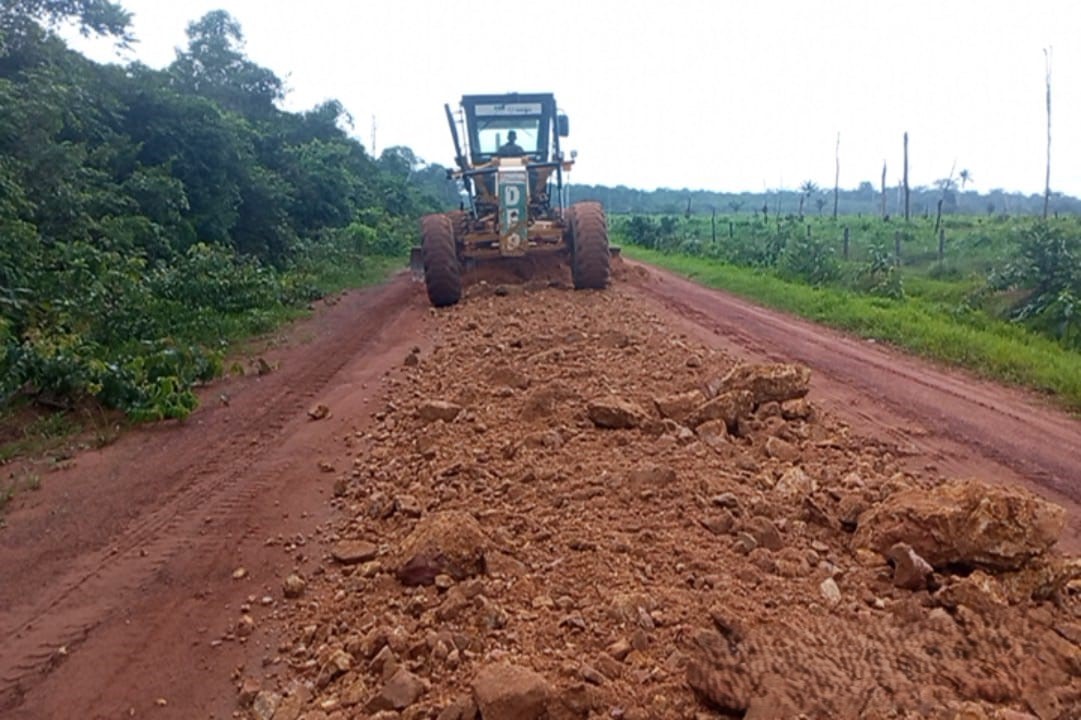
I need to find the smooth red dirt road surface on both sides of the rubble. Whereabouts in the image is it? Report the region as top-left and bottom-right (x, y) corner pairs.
(0, 265), (1081, 720)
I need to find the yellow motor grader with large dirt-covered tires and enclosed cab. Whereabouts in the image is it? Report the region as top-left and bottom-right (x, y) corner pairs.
(411, 93), (610, 307)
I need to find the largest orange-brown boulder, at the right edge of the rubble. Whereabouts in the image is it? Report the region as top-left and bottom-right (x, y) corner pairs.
(853, 480), (1065, 570)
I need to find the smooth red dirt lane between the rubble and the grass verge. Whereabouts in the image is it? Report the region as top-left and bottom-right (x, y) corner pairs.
(627, 262), (1081, 548)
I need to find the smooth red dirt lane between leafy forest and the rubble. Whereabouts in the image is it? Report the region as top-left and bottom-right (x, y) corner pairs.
(0, 276), (427, 719)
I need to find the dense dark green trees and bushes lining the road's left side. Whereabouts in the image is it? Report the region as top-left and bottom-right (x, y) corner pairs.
(0, 0), (453, 418)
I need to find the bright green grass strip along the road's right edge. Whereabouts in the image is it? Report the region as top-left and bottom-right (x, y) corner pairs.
(623, 244), (1081, 412)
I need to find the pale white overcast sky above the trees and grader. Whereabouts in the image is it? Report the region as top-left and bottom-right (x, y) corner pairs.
(72, 0), (1081, 196)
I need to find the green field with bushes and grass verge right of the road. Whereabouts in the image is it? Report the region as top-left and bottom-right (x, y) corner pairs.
(613, 210), (1081, 409)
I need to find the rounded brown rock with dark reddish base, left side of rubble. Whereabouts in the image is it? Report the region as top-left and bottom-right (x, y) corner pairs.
(398, 503), (489, 585)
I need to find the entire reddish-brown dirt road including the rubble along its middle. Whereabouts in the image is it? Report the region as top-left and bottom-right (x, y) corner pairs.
(0, 264), (1081, 720)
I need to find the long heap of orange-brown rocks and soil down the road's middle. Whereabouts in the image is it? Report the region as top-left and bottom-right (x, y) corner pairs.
(238, 289), (1081, 720)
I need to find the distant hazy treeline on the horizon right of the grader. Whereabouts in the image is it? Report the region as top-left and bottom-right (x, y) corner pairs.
(570, 182), (1081, 217)
